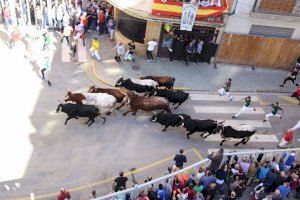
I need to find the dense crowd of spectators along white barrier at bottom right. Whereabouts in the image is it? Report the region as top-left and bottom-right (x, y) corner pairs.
(91, 149), (300, 200)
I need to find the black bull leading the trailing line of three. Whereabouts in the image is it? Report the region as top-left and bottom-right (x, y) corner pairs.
(150, 113), (190, 131)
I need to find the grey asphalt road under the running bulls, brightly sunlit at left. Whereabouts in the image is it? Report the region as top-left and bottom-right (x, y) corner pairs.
(0, 28), (300, 199)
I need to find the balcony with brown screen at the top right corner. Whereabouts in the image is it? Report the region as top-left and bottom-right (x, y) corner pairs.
(251, 0), (300, 21)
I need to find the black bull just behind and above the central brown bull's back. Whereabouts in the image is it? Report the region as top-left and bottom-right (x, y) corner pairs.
(149, 88), (189, 109)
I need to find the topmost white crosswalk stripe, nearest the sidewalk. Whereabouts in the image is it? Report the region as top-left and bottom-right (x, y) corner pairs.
(190, 93), (258, 102)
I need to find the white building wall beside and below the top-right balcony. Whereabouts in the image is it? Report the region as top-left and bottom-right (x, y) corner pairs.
(225, 0), (300, 39)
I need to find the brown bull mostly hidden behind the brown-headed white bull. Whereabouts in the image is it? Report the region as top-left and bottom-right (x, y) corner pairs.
(88, 85), (128, 110)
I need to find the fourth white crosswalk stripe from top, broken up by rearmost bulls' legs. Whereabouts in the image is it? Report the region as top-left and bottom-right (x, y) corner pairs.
(205, 134), (278, 142)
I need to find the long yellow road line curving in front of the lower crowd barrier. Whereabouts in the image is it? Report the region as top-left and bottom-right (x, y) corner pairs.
(11, 149), (193, 200)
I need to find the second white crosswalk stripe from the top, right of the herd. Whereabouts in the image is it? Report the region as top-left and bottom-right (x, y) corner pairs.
(194, 105), (265, 115)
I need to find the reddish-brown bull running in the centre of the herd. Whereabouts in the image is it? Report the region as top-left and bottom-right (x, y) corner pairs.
(123, 91), (171, 116)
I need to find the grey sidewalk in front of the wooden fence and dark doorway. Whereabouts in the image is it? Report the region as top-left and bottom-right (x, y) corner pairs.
(94, 51), (299, 92)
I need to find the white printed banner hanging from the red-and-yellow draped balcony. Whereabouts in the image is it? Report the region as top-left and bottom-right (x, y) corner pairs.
(180, 3), (198, 31)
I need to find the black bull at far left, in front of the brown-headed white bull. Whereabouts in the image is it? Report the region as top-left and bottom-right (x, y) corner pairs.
(56, 103), (106, 126)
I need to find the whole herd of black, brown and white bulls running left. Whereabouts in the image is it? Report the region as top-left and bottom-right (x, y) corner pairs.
(56, 76), (256, 146)
